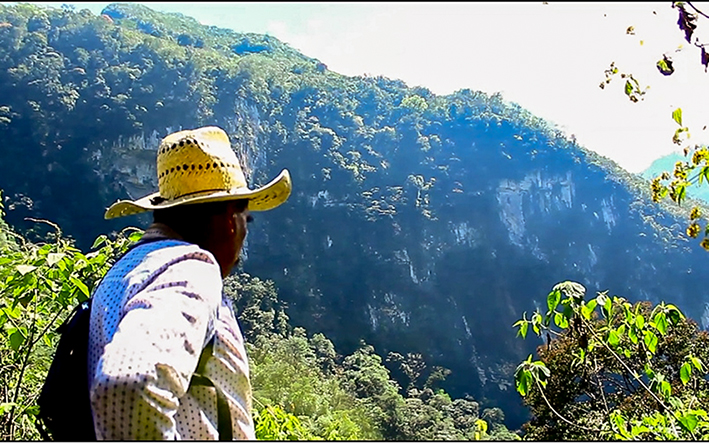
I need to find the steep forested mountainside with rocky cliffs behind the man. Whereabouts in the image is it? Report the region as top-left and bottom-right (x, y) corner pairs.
(0, 4), (709, 427)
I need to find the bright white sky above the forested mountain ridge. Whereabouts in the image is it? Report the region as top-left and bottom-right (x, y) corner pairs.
(15, 1), (709, 172)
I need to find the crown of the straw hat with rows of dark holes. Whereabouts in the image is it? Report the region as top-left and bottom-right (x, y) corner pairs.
(157, 126), (247, 201)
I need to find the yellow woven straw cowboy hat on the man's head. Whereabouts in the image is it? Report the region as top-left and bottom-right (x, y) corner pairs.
(104, 126), (292, 219)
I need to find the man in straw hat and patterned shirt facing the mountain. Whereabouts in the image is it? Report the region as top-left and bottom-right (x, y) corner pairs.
(88, 127), (291, 440)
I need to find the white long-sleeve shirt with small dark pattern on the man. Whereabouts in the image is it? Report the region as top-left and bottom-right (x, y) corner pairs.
(88, 239), (255, 440)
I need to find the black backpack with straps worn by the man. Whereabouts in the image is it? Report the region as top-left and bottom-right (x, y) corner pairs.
(35, 243), (232, 441)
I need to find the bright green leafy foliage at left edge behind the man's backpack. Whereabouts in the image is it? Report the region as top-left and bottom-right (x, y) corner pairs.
(0, 220), (141, 440)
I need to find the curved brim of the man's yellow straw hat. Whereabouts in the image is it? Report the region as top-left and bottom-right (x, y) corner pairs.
(104, 169), (293, 219)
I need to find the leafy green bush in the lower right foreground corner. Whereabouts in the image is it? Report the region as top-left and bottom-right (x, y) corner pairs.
(514, 282), (709, 440)
